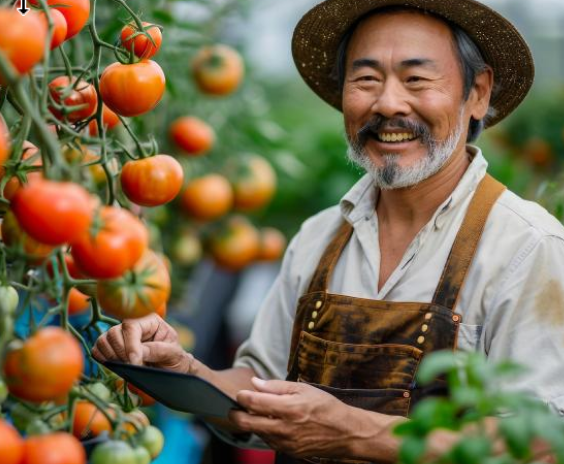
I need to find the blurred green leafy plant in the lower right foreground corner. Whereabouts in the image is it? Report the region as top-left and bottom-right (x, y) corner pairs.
(395, 351), (564, 464)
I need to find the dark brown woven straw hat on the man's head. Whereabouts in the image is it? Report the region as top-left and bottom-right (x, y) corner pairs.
(292, 0), (535, 127)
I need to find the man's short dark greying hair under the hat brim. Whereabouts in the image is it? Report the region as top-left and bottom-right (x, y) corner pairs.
(334, 7), (499, 143)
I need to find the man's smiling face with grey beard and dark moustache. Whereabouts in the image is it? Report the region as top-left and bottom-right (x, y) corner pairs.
(343, 12), (472, 189)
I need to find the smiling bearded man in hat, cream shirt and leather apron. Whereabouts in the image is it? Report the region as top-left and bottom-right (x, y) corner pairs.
(94, 0), (564, 463)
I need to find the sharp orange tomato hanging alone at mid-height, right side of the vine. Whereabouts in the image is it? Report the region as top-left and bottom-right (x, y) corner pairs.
(121, 155), (184, 206)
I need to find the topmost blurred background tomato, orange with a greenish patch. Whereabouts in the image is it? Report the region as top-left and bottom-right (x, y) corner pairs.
(192, 45), (245, 95)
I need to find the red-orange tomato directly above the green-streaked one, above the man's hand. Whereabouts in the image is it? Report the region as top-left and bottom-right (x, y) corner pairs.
(71, 206), (149, 279)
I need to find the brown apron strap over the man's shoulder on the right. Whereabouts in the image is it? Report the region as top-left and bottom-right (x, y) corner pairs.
(433, 174), (506, 310)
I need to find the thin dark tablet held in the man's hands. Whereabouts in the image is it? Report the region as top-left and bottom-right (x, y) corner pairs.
(102, 361), (243, 418)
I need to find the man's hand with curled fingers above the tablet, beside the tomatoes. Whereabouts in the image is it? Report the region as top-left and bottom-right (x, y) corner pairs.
(92, 313), (195, 373)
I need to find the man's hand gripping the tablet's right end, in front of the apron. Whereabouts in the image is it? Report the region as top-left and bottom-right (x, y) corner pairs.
(229, 378), (366, 457)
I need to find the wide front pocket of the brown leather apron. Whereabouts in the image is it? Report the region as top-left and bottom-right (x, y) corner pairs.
(297, 331), (423, 391)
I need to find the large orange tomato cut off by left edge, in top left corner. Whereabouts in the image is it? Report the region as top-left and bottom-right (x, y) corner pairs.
(0, 8), (47, 85)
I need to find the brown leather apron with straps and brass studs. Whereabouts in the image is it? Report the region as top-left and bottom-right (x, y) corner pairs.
(276, 175), (505, 464)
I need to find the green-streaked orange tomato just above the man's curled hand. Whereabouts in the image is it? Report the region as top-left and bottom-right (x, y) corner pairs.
(97, 250), (170, 319)
